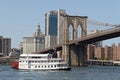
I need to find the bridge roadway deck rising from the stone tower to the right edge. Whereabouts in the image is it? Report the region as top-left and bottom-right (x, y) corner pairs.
(69, 27), (120, 45)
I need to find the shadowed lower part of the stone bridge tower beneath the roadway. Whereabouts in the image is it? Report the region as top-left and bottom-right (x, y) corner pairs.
(69, 45), (87, 66)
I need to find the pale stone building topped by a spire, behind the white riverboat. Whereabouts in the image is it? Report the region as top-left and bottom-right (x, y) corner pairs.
(21, 24), (45, 53)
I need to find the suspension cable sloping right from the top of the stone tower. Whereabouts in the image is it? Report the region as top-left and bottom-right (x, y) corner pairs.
(87, 19), (120, 27)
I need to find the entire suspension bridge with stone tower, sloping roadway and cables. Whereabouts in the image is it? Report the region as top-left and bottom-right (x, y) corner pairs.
(39, 15), (120, 66)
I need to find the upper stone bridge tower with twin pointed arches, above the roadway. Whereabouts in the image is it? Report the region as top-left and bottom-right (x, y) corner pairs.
(63, 15), (87, 43)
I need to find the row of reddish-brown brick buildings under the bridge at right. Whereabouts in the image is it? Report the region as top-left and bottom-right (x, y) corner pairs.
(87, 44), (120, 60)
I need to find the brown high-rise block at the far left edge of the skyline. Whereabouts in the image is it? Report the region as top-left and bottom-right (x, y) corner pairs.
(0, 36), (11, 56)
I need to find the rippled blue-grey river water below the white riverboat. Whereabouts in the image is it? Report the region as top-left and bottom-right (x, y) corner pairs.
(0, 65), (120, 80)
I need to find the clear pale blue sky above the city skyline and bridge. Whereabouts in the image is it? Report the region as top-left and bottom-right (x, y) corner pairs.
(0, 0), (120, 48)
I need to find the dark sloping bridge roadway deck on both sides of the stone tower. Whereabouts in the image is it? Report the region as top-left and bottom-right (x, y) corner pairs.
(39, 27), (120, 53)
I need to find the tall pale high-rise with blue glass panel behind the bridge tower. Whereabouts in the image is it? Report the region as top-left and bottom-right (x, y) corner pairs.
(45, 9), (66, 48)
